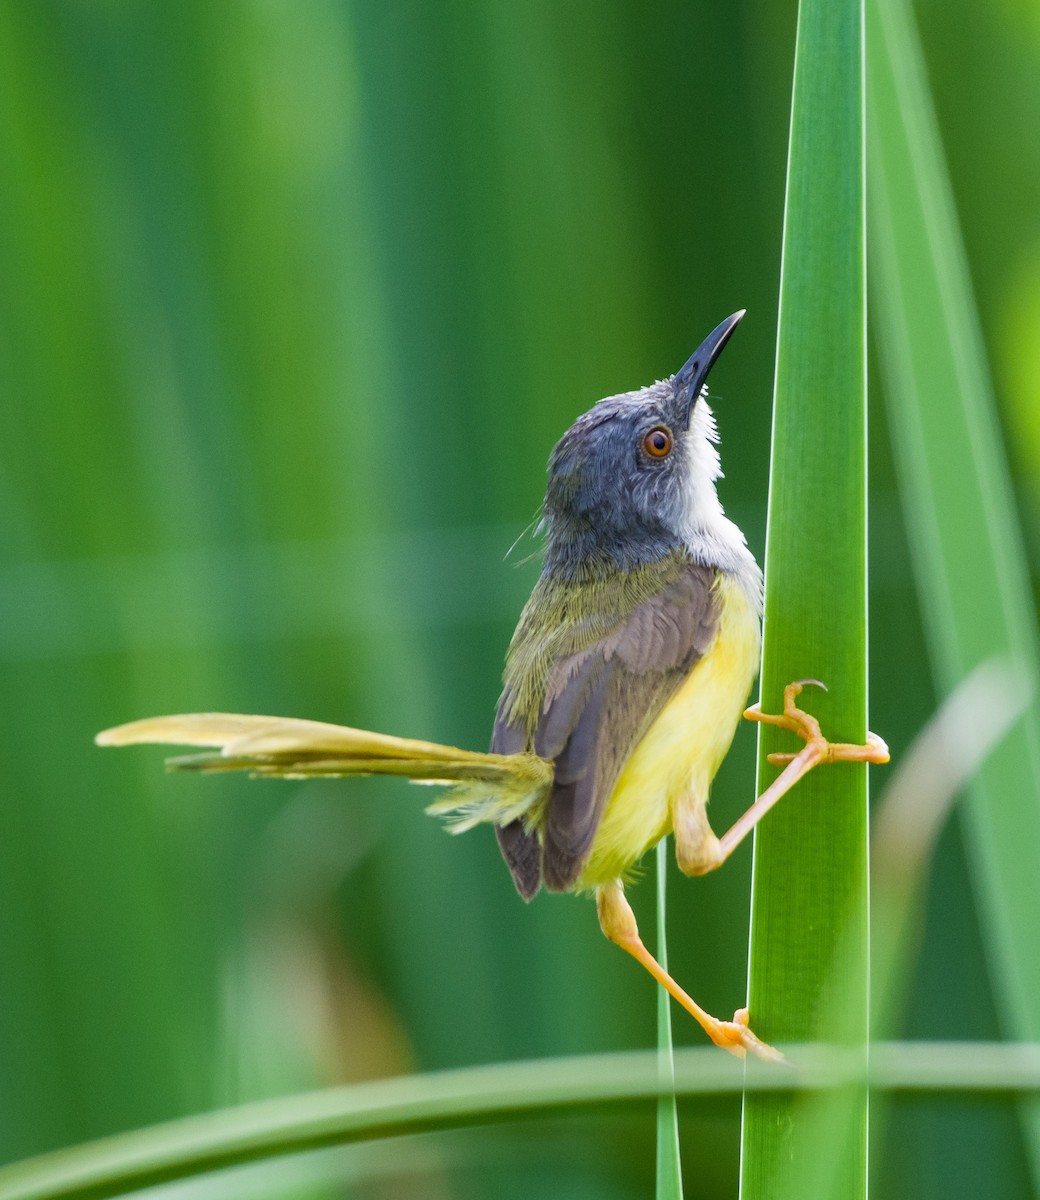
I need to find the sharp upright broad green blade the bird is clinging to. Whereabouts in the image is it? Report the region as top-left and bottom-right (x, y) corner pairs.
(741, 0), (867, 1200)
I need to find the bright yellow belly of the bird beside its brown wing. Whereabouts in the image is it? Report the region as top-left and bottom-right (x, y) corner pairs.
(577, 576), (761, 892)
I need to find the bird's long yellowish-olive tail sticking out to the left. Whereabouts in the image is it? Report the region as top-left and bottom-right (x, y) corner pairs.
(95, 713), (553, 833)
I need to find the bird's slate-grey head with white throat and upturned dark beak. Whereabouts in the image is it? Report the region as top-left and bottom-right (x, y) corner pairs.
(542, 310), (744, 578)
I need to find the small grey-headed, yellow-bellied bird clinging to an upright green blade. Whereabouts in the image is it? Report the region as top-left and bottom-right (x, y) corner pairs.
(96, 310), (888, 1060)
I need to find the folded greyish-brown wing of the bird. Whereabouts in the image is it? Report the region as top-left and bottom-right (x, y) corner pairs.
(492, 563), (719, 899)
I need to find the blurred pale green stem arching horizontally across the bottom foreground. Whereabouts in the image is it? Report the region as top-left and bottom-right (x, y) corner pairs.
(10, 1042), (1040, 1200)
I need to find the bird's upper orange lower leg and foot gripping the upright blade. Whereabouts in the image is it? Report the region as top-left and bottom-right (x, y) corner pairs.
(711, 679), (889, 866)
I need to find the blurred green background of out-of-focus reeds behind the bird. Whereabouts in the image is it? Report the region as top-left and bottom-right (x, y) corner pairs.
(0, 0), (1040, 1200)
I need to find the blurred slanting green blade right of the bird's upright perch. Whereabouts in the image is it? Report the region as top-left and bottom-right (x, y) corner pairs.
(870, 0), (1040, 1187)
